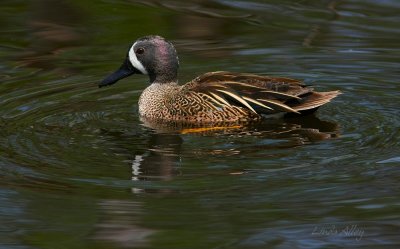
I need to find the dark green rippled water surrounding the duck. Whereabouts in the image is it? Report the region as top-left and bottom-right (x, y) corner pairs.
(0, 0), (400, 249)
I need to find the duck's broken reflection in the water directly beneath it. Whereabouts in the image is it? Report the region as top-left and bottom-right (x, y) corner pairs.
(132, 114), (339, 193)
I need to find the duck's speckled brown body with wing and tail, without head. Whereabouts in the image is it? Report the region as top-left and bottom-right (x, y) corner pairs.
(139, 72), (339, 123)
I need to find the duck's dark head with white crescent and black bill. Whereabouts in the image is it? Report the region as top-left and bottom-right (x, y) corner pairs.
(99, 36), (179, 87)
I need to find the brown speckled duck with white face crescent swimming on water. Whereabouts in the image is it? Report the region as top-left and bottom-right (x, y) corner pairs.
(98, 35), (341, 124)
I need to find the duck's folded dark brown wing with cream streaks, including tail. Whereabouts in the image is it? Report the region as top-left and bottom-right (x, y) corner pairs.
(183, 71), (340, 114)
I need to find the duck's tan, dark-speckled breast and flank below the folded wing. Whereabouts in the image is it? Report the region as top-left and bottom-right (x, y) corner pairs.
(139, 80), (260, 123)
